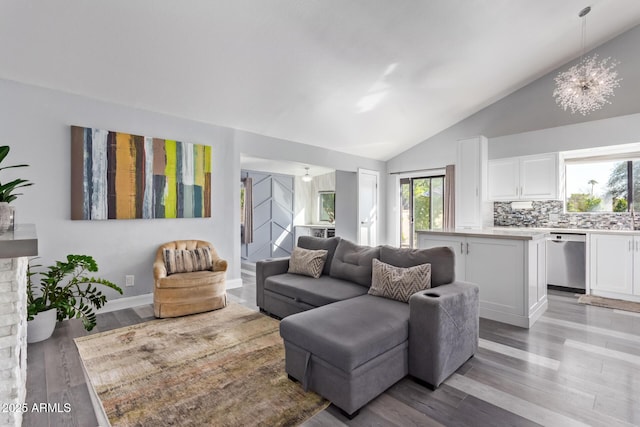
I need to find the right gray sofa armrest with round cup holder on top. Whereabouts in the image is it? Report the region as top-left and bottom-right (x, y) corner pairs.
(409, 281), (479, 388)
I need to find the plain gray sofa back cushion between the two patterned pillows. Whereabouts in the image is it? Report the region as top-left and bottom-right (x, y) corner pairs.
(330, 239), (380, 288)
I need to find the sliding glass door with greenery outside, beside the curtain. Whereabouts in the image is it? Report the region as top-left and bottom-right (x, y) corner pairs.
(400, 176), (444, 248)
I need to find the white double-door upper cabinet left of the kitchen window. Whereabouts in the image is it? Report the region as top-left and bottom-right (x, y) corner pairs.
(487, 153), (558, 200)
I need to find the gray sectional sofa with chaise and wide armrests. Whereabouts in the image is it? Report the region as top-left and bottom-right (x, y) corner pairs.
(256, 236), (479, 416)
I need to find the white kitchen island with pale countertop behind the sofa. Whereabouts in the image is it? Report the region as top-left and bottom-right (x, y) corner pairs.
(417, 228), (548, 328)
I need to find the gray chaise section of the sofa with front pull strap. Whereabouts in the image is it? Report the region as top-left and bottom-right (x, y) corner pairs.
(280, 295), (409, 415)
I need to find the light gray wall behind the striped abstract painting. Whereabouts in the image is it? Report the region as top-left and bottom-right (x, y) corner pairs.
(0, 80), (385, 299)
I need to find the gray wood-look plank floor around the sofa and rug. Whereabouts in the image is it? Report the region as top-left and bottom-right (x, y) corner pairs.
(23, 266), (640, 427)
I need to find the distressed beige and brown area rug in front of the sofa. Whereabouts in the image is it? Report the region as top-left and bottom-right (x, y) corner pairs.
(75, 303), (329, 426)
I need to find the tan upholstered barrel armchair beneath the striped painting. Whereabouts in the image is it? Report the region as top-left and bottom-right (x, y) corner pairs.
(153, 240), (227, 317)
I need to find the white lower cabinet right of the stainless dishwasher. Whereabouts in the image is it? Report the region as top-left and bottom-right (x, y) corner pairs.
(589, 233), (640, 298)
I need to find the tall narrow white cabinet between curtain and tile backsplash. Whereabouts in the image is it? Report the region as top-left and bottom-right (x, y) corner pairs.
(455, 136), (487, 228)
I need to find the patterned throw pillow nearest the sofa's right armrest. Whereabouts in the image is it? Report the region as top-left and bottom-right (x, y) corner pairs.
(369, 259), (431, 302)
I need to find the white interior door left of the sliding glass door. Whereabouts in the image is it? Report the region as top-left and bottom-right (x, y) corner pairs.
(358, 169), (379, 246)
